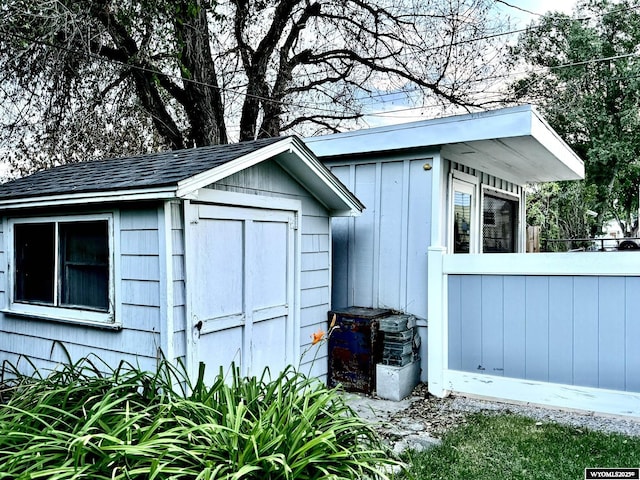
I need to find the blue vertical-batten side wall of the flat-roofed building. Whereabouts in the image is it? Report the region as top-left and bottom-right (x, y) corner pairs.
(326, 156), (432, 319)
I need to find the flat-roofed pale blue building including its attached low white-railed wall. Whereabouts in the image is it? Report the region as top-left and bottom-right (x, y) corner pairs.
(305, 105), (640, 416)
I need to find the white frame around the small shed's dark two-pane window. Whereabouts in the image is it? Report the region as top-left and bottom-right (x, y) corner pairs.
(3, 211), (122, 329)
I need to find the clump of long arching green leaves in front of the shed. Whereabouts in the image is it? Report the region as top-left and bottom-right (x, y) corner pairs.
(0, 359), (396, 480)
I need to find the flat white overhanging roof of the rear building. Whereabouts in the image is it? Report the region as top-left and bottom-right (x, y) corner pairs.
(305, 105), (584, 184)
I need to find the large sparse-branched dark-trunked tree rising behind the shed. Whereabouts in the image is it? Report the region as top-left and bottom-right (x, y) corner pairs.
(0, 0), (510, 175)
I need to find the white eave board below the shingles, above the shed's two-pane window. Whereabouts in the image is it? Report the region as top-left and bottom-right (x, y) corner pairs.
(0, 186), (176, 210)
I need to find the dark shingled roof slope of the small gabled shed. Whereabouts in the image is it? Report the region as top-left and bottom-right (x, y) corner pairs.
(0, 137), (287, 199)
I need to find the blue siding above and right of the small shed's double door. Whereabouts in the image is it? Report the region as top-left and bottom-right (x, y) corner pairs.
(208, 161), (331, 379)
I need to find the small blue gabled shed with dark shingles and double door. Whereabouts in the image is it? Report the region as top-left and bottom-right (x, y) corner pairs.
(0, 137), (363, 386)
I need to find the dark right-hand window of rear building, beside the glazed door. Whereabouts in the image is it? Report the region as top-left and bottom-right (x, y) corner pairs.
(482, 191), (518, 253)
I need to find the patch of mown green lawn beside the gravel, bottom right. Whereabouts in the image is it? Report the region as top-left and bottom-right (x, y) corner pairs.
(397, 414), (640, 480)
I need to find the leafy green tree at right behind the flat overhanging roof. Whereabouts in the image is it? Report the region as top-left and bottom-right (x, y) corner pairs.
(511, 0), (640, 233)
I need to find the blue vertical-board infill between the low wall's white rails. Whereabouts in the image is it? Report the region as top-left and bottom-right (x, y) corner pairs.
(448, 275), (640, 392)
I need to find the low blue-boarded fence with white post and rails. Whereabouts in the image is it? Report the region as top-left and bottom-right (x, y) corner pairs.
(428, 248), (640, 416)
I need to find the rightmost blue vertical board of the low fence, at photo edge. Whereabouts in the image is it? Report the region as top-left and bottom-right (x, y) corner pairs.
(624, 277), (640, 392)
